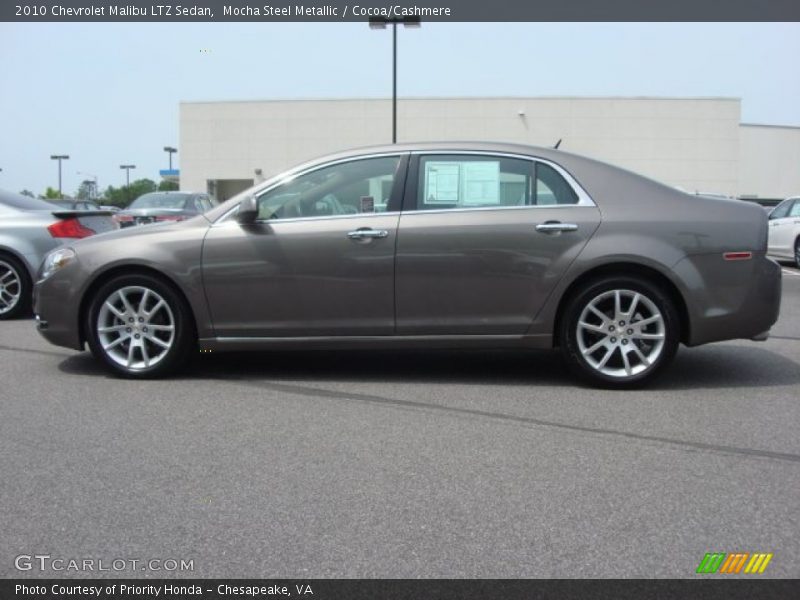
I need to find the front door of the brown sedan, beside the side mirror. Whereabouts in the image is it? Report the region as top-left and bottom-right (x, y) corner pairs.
(203, 154), (407, 337)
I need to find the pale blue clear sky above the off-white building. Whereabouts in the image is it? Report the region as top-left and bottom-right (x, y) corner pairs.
(0, 23), (800, 193)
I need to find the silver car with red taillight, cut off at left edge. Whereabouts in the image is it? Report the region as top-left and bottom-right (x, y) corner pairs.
(0, 190), (117, 319)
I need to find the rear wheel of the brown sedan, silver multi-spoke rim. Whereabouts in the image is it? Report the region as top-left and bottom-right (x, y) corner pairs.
(558, 276), (681, 389)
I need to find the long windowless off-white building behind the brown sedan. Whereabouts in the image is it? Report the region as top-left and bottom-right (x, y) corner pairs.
(180, 97), (800, 200)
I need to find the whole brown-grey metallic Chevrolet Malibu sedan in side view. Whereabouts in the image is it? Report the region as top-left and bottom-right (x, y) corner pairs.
(35, 143), (781, 387)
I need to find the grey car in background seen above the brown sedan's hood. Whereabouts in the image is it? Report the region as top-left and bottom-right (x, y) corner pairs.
(114, 192), (216, 227)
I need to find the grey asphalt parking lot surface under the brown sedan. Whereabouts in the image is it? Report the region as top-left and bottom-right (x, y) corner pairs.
(0, 268), (800, 578)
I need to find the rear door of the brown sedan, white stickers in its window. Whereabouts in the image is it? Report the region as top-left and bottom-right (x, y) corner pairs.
(396, 153), (600, 335)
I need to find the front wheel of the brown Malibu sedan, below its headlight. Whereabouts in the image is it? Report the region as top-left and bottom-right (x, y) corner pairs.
(84, 274), (196, 379)
